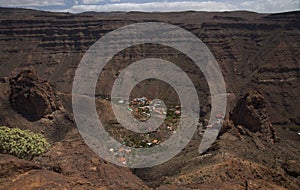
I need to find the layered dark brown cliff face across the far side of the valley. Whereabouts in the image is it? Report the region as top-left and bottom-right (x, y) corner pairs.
(0, 9), (300, 124)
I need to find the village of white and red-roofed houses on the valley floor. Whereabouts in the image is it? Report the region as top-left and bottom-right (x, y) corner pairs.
(107, 96), (181, 164)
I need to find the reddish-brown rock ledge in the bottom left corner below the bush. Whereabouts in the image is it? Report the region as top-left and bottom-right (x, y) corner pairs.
(0, 154), (98, 190)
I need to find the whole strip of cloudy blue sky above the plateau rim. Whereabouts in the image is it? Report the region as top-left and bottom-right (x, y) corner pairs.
(0, 0), (300, 13)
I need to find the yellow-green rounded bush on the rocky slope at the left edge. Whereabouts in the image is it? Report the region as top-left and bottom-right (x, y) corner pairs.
(0, 126), (50, 160)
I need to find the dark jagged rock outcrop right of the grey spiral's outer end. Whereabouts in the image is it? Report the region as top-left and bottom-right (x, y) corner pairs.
(230, 91), (275, 140)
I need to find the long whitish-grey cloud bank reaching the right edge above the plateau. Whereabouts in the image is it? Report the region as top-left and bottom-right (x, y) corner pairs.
(65, 0), (299, 13)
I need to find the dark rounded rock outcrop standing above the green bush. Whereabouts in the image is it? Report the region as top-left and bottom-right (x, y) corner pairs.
(10, 70), (61, 121)
